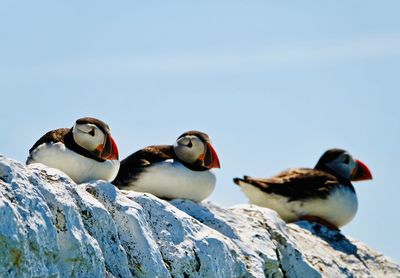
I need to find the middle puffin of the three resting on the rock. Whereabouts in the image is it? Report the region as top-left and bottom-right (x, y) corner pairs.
(112, 131), (220, 202)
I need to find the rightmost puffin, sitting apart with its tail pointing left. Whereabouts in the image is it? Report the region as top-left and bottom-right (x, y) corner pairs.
(234, 148), (372, 230)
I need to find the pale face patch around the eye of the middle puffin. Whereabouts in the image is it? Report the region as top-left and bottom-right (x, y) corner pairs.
(174, 135), (206, 163)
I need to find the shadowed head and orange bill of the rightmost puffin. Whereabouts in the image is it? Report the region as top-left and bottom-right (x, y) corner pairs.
(315, 149), (372, 181)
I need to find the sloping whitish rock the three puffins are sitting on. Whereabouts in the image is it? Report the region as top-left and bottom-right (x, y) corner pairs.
(0, 156), (400, 277)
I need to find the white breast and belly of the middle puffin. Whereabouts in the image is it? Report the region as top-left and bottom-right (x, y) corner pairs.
(124, 161), (216, 202)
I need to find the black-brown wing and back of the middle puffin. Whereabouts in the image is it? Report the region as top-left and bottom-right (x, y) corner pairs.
(112, 145), (174, 187)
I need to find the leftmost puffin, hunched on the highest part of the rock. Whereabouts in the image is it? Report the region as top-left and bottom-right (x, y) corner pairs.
(26, 117), (120, 184)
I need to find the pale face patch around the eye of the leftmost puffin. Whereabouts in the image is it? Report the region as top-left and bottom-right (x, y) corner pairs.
(72, 123), (106, 151)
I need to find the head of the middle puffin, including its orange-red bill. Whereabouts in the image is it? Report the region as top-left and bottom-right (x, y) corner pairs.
(174, 131), (220, 169)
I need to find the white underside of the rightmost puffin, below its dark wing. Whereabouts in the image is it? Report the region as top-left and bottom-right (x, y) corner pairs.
(241, 182), (358, 227)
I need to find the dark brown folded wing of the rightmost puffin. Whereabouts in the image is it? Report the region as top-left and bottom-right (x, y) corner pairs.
(234, 168), (339, 201)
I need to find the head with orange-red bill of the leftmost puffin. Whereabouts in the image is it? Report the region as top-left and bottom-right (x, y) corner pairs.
(72, 117), (118, 160)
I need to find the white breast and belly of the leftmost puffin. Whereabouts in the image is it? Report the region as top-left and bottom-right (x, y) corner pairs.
(27, 142), (119, 183)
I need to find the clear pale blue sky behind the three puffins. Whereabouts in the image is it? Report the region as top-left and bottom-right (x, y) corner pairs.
(0, 0), (400, 262)
